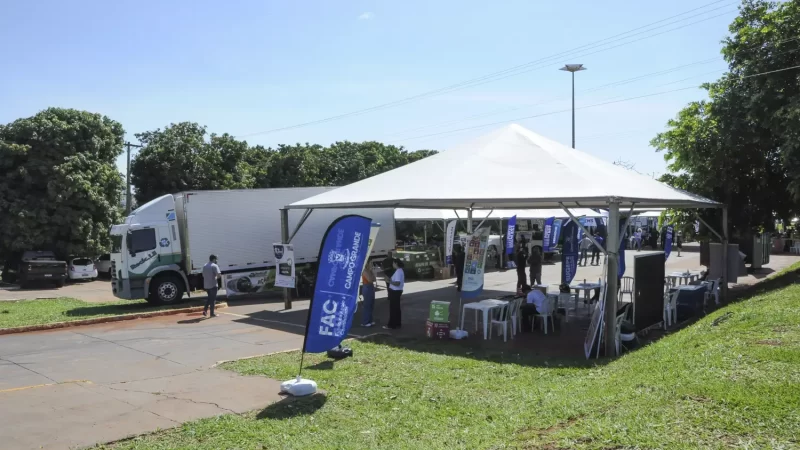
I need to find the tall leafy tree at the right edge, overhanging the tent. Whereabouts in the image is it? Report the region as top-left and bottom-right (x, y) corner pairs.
(651, 0), (800, 234)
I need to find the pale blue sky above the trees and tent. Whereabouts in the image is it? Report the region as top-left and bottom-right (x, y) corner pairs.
(0, 0), (737, 178)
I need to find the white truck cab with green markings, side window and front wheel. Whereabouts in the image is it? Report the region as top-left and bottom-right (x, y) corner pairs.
(110, 195), (191, 304)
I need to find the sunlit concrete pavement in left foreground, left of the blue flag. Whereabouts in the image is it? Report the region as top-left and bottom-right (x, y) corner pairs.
(0, 311), (303, 449)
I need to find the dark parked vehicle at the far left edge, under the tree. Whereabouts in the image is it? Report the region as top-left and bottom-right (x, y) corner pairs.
(3, 250), (67, 288)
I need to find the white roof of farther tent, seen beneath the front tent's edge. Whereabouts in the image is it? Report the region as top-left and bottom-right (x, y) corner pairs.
(394, 208), (608, 221)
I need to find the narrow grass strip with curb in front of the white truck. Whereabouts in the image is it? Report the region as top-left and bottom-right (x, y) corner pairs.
(0, 297), (206, 328)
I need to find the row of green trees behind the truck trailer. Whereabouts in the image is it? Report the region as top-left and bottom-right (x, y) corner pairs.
(131, 122), (436, 205)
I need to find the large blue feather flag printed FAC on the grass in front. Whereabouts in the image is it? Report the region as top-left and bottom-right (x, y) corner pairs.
(303, 216), (372, 353)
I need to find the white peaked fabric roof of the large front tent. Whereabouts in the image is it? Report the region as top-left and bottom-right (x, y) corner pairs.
(287, 125), (721, 209)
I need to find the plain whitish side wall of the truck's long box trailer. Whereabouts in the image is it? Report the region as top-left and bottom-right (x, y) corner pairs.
(184, 187), (395, 273)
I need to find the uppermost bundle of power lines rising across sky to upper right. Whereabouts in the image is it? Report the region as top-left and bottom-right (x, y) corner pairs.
(237, 0), (736, 138)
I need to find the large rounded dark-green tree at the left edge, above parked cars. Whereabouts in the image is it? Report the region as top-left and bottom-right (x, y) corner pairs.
(0, 108), (124, 259)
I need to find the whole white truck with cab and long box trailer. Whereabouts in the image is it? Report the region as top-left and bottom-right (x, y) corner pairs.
(111, 187), (395, 304)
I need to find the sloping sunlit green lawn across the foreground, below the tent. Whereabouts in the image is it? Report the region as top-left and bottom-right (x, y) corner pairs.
(108, 268), (800, 449)
